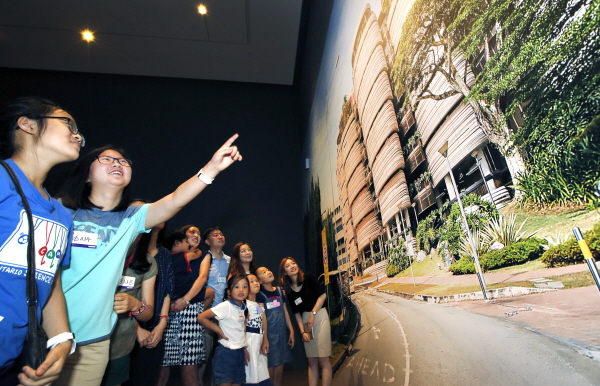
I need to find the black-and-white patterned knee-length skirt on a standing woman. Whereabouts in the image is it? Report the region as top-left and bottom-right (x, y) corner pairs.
(163, 302), (206, 366)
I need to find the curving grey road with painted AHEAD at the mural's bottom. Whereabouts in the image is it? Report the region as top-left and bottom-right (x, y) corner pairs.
(333, 291), (600, 386)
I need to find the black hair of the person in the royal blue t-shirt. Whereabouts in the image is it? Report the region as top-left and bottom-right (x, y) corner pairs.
(0, 96), (64, 159)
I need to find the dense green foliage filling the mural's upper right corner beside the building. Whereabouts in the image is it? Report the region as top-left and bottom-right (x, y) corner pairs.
(450, 0), (600, 207)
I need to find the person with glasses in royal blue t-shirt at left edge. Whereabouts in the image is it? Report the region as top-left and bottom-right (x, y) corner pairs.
(0, 97), (84, 385)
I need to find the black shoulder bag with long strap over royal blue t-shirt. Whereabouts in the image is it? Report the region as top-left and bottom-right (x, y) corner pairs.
(0, 160), (48, 369)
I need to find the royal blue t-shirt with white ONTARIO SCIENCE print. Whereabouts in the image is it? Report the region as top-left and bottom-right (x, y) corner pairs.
(0, 160), (72, 368)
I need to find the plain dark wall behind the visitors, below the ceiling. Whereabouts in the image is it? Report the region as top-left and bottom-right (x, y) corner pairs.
(0, 68), (304, 269)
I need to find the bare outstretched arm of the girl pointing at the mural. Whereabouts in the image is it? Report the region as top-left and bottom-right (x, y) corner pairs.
(145, 134), (242, 229)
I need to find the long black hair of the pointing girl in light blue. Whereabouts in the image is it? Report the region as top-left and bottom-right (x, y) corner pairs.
(57, 145), (131, 212)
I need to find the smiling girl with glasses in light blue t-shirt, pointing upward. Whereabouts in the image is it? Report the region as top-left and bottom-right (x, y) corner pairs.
(55, 134), (242, 386)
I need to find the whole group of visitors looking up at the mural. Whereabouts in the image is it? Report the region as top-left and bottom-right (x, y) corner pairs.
(0, 97), (332, 386)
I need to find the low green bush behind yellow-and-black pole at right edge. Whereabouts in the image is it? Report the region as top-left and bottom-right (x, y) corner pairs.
(541, 222), (600, 268)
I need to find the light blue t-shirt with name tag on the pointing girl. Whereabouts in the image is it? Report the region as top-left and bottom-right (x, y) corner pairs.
(61, 204), (150, 345)
